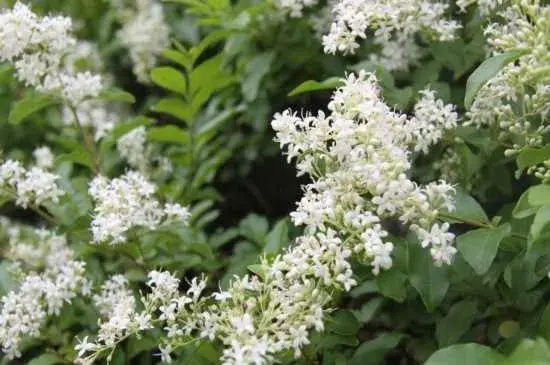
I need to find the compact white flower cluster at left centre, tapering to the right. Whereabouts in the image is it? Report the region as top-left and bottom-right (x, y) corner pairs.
(89, 171), (190, 245)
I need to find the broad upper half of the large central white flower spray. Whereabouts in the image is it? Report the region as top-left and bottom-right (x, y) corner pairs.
(272, 72), (457, 273)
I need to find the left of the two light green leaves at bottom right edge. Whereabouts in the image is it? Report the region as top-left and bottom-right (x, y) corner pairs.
(424, 343), (504, 365)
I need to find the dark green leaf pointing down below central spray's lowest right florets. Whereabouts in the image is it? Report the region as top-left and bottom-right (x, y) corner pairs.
(407, 238), (449, 312)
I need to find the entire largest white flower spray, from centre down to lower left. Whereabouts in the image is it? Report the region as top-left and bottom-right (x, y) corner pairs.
(73, 72), (456, 365)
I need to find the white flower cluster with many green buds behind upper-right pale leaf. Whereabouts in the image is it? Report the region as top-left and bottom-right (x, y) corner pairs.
(467, 0), (550, 160)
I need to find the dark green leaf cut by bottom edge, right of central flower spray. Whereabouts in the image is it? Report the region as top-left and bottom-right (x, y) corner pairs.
(349, 332), (406, 365)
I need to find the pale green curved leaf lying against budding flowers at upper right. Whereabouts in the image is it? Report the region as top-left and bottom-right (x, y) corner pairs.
(464, 51), (523, 109)
